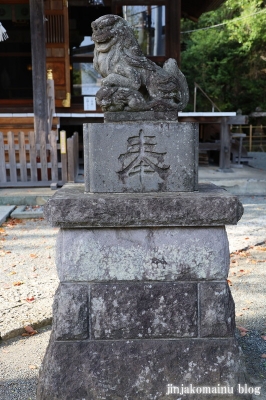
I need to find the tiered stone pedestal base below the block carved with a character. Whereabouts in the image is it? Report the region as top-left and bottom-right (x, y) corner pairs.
(37, 185), (251, 400)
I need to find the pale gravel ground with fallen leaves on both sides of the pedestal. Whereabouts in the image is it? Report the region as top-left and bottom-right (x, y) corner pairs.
(0, 197), (266, 400)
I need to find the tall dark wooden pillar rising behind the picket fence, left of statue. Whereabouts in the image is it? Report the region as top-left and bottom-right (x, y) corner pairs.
(30, 0), (48, 143)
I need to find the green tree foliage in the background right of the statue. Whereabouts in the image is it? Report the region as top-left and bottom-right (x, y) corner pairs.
(181, 0), (266, 114)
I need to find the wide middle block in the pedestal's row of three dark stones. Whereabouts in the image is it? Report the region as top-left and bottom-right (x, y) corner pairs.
(90, 283), (198, 339)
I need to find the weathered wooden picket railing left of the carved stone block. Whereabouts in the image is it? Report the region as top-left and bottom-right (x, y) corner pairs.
(0, 131), (67, 187)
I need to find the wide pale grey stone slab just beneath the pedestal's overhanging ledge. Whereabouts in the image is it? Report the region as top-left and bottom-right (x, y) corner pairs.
(56, 227), (229, 282)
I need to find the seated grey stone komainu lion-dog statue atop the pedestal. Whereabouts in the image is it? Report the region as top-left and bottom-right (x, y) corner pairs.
(92, 15), (189, 111)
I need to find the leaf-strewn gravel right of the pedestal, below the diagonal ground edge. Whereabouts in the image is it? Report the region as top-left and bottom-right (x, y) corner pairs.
(228, 245), (266, 400)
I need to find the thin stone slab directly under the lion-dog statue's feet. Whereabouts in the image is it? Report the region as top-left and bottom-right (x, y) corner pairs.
(104, 111), (178, 123)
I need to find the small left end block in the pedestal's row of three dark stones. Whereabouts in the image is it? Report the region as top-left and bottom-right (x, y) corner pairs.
(53, 283), (88, 340)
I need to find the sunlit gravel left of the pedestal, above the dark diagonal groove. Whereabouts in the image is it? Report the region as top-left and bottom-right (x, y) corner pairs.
(0, 219), (58, 339)
